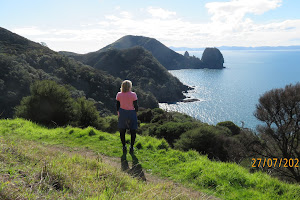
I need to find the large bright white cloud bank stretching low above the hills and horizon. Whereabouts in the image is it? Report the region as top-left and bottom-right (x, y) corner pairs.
(11, 0), (300, 53)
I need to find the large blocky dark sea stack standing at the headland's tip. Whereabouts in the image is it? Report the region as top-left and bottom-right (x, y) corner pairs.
(201, 48), (224, 69)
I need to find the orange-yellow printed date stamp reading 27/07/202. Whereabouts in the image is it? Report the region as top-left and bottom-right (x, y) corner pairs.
(252, 158), (299, 167)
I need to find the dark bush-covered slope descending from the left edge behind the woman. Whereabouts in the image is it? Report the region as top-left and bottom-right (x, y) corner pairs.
(0, 27), (158, 117)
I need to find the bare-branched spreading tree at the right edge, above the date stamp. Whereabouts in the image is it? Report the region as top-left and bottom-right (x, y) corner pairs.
(254, 83), (300, 182)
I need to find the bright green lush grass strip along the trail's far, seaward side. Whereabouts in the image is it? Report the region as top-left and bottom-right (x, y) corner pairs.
(0, 119), (300, 199)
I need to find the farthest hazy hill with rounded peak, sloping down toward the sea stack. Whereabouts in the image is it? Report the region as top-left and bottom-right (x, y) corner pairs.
(62, 35), (224, 70)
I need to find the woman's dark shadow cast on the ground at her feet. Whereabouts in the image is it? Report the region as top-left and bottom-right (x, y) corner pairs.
(121, 151), (147, 181)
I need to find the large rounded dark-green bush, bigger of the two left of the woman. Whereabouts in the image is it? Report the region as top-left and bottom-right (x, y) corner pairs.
(15, 80), (76, 126)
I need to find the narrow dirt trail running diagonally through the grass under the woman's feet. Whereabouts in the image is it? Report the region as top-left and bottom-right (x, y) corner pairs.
(47, 145), (219, 200)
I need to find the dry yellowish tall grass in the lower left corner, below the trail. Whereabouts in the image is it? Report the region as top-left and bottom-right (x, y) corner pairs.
(0, 137), (202, 200)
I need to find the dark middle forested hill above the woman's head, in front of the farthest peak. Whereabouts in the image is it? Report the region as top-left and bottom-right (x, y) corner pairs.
(63, 46), (188, 102)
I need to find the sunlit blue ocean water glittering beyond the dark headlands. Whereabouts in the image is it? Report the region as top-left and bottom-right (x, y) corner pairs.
(160, 50), (300, 129)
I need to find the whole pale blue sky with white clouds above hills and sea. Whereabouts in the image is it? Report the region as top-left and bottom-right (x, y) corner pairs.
(0, 0), (300, 53)
